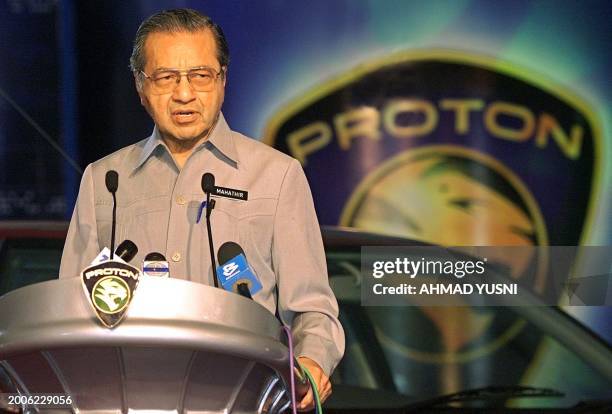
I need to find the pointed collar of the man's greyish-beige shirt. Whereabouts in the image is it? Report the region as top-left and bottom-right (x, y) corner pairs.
(134, 113), (239, 170)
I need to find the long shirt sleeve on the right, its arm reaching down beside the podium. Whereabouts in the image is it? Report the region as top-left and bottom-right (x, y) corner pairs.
(272, 160), (344, 375)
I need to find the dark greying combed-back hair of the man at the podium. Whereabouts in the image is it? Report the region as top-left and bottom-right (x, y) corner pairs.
(130, 9), (229, 74)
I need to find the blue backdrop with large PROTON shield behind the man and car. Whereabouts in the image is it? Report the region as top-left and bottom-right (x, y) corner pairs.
(0, 0), (612, 402)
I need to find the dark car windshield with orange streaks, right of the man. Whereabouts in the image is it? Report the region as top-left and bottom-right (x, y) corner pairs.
(328, 247), (612, 408)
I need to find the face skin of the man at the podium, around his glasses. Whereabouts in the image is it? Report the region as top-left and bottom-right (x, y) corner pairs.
(137, 29), (225, 145)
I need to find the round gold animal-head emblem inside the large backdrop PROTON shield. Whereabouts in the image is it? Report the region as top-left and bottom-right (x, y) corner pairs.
(340, 145), (548, 292)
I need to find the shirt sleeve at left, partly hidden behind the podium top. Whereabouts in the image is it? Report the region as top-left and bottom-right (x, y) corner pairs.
(59, 165), (100, 278)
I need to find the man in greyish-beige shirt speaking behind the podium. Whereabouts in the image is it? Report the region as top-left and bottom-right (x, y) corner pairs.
(60, 9), (344, 410)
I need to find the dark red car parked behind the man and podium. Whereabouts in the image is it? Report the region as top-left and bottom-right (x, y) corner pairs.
(0, 222), (612, 413)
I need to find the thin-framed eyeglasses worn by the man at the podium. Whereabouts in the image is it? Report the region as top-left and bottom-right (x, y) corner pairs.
(140, 66), (223, 95)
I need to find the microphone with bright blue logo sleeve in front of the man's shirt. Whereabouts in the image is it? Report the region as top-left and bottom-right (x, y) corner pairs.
(217, 242), (262, 299)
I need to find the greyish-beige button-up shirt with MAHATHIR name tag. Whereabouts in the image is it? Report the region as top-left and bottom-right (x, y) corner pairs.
(60, 115), (344, 374)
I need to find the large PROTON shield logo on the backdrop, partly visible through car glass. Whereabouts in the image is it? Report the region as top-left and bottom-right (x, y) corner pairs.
(265, 51), (601, 392)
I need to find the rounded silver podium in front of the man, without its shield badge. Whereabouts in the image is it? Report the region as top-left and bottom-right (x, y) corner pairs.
(0, 277), (306, 413)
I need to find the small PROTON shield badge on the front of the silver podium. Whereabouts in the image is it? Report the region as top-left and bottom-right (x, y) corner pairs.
(82, 260), (140, 328)
